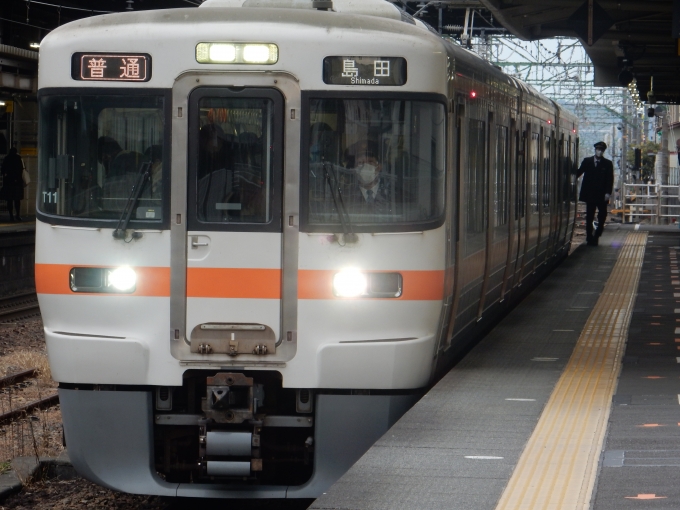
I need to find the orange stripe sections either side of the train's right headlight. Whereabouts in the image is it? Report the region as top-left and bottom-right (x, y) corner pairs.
(298, 269), (444, 301)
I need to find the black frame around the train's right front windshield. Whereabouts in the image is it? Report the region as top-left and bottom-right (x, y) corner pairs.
(300, 90), (450, 233)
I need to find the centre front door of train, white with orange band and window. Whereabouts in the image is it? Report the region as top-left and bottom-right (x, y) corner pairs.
(186, 87), (283, 355)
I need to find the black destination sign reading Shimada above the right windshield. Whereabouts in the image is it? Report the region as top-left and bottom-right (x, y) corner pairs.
(323, 57), (406, 86)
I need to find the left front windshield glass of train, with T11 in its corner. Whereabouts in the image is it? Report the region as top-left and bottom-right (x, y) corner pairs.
(38, 94), (167, 227)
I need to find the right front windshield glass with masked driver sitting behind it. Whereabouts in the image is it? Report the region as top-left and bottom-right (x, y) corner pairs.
(307, 98), (446, 231)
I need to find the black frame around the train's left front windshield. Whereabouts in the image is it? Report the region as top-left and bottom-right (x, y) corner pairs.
(35, 87), (172, 230)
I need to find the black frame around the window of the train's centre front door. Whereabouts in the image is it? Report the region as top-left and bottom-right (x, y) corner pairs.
(186, 85), (285, 233)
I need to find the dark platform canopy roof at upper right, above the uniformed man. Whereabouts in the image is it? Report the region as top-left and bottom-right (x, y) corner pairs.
(480, 0), (680, 102)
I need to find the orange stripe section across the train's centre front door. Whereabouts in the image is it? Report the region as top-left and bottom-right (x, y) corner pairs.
(187, 268), (281, 299)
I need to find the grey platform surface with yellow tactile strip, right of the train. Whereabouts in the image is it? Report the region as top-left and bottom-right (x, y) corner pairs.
(310, 225), (680, 510)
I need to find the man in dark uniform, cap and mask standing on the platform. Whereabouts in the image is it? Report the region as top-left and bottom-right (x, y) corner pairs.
(577, 142), (614, 246)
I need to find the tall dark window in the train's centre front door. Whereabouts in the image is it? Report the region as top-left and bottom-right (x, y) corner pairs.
(189, 89), (282, 230)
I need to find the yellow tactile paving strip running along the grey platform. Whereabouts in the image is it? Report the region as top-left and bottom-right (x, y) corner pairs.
(496, 232), (647, 510)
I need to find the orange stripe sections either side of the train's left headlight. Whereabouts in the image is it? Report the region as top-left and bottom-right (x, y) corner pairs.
(35, 264), (170, 297)
